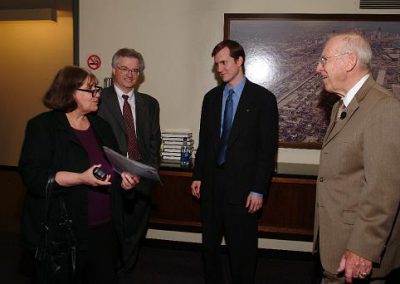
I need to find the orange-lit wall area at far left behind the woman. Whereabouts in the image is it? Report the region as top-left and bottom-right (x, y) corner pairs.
(0, 11), (73, 166)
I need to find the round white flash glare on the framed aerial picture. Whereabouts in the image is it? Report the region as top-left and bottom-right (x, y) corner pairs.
(245, 47), (280, 89)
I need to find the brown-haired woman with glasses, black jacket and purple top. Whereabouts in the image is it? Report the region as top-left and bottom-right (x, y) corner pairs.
(19, 66), (137, 284)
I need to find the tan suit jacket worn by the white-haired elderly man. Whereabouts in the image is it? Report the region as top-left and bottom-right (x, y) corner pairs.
(314, 77), (400, 277)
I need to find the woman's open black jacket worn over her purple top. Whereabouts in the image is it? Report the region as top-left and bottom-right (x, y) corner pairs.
(19, 111), (123, 251)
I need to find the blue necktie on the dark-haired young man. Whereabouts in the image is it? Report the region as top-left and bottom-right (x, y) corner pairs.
(217, 89), (235, 166)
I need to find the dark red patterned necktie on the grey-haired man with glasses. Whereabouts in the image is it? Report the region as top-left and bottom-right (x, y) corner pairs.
(122, 95), (140, 160)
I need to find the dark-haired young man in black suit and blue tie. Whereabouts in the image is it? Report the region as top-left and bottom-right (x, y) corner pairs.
(191, 40), (278, 283)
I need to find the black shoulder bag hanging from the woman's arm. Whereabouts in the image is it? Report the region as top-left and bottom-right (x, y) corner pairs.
(35, 176), (76, 284)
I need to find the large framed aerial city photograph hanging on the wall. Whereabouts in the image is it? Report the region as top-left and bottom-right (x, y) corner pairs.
(224, 14), (400, 149)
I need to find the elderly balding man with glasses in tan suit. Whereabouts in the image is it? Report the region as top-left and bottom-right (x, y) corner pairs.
(314, 33), (400, 283)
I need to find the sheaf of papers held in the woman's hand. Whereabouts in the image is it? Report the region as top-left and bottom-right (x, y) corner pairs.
(103, 146), (161, 182)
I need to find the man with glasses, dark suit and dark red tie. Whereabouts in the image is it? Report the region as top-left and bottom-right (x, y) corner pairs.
(98, 48), (161, 280)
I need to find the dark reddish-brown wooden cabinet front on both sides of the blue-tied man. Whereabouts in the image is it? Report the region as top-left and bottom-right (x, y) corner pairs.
(150, 170), (316, 240)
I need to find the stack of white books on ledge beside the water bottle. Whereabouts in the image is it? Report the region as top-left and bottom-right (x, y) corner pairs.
(161, 129), (194, 162)
